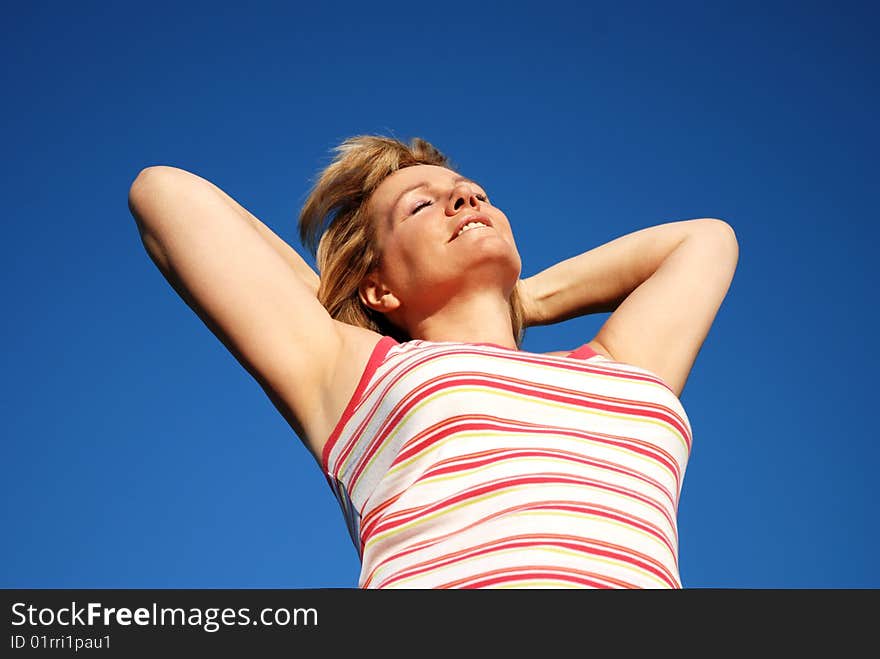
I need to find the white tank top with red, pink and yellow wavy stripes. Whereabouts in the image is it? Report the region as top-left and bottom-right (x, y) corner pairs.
(321, 337), (692, 588)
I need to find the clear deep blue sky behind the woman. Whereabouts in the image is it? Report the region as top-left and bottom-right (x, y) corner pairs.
(0, 2), (880, 588)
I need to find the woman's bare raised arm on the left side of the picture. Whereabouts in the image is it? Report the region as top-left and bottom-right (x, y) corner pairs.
(129, 166), (350, 455)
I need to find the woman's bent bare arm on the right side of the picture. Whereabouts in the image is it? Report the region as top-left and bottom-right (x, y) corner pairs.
(521, 218), (739, 394)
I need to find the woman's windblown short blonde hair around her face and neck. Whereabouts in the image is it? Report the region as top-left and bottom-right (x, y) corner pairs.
(299, 135), (523, 346)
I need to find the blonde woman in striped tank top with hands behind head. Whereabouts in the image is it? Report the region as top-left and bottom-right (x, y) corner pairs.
(129, 136), (738, 588)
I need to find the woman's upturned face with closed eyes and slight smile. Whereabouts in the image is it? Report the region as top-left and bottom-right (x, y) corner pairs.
(360, 165), (521, 312)
